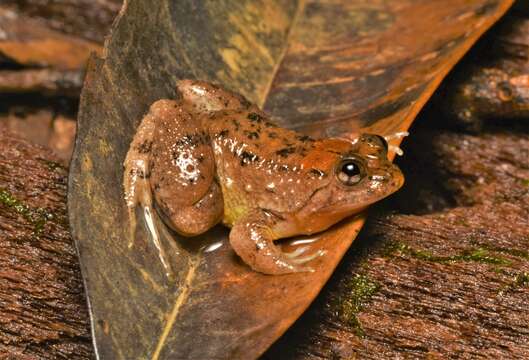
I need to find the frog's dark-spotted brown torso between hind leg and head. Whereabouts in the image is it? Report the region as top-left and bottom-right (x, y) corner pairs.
(209, 110), (326, 224)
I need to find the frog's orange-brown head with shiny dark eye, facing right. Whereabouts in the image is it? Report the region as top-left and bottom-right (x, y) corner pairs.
(298, 134), (404, 233)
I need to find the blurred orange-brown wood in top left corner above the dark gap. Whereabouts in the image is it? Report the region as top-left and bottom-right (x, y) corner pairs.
(0, 0), (121, 96)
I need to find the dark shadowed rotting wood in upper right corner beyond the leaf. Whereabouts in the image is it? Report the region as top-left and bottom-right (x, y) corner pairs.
(435, 1), (529, 130)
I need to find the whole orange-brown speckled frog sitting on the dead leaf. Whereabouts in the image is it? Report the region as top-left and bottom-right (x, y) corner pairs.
(124, 80), (404, 274)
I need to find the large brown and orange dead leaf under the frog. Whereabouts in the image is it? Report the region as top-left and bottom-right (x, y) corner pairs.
(69, 0), (511, 359)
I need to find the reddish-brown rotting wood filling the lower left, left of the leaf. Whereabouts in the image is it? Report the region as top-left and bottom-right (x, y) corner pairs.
(0, 131), (93, 360)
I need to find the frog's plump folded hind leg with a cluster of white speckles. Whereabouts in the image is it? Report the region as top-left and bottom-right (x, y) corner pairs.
(150, 100), (223, 236)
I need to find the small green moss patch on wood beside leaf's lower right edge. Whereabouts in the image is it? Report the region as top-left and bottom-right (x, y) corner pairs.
(332, 274), (380, 337)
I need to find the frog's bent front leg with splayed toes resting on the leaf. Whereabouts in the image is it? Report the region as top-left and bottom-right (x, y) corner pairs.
(230, 210), (322, 275)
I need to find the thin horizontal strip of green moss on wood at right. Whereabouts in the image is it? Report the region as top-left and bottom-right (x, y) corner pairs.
(386, 242), (511, 265)
